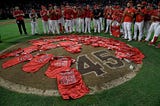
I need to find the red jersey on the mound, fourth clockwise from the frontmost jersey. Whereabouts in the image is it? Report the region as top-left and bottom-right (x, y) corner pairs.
(2, 54), (33, 68)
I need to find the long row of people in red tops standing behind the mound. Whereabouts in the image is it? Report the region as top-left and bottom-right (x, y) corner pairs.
(13, 1), (160, 45)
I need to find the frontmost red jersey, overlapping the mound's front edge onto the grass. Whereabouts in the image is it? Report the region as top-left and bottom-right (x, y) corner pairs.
(57, 68), (89, 99)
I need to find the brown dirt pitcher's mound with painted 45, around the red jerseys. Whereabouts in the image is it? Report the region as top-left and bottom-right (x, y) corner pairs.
(0, 35), (142, 96)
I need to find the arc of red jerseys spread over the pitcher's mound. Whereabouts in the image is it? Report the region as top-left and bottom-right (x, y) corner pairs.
(0, 35), (144, 99)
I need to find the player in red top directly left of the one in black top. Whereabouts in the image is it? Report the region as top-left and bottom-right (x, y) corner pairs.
(85, 5), (92, 33)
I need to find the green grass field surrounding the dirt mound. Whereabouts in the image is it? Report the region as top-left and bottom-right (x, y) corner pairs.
(0, 19), (160, 106)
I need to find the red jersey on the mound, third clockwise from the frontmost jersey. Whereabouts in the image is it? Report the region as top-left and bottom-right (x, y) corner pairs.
(22, 54), (53, 72)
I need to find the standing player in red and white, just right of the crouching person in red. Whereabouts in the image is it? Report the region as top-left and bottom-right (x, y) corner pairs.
(122, 1), (135, 41)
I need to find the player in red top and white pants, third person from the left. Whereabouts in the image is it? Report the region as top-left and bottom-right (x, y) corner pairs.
(40, 5), (49, 34)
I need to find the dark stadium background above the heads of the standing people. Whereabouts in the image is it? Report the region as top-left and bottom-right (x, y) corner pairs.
(0, 0), (159, 19)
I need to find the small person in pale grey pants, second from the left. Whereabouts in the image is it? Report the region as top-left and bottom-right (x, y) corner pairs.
(29, 9), (38, 35)
